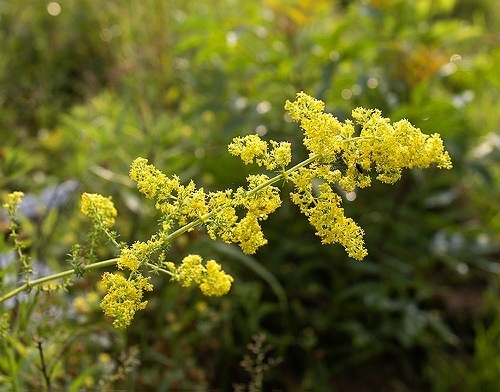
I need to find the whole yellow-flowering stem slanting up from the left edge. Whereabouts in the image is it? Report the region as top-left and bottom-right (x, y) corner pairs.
(0, 92), (452, 328)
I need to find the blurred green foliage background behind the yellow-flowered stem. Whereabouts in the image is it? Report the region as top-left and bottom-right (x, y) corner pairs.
(0, 0), (500, 391)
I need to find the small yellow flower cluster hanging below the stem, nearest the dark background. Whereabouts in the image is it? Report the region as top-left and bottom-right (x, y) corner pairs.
(167, 255), (234, 296)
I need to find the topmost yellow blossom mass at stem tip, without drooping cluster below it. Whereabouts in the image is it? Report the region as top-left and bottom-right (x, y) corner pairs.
(285, 93), (452, 191)
